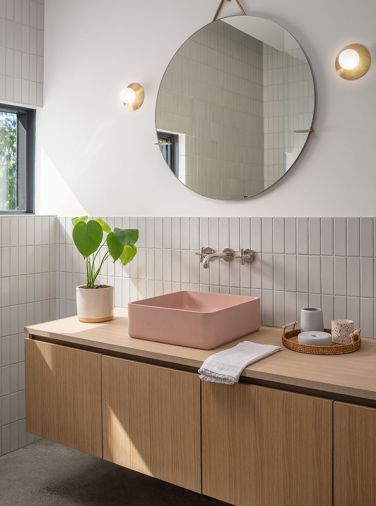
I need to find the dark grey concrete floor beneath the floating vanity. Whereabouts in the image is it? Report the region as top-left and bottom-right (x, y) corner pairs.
(0, 440), (225, 506)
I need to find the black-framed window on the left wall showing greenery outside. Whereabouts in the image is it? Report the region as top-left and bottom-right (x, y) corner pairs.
(0, 104), (35, 214)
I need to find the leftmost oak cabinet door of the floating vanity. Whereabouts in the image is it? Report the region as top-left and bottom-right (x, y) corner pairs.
(25, 339), (102, 457)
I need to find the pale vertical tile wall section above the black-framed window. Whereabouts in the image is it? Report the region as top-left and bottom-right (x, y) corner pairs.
(0, 0), (44, 107)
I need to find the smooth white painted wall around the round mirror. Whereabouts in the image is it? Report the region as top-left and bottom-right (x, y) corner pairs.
(37, 0), (376, 216)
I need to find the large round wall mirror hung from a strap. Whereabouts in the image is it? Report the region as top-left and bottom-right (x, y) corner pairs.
(156, 16), (315, 200)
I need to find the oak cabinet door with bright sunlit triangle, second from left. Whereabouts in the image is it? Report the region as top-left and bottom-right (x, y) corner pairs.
(102, 356), (201, 492)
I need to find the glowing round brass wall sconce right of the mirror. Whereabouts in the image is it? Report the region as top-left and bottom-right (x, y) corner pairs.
(336, 44), (371, 80)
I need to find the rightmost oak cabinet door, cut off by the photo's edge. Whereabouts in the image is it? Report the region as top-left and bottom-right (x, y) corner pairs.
(334, 402), (376, 506)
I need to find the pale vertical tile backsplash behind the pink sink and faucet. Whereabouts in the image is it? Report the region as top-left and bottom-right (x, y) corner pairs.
(55, 217), (376, 337)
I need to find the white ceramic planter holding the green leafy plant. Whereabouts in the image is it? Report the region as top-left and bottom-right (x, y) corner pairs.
(76, 286), (114, 323)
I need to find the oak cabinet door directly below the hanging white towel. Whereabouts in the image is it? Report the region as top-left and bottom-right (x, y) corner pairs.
(202, 383), (332, 506)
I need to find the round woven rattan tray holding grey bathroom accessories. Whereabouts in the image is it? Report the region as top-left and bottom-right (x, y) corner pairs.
(282, 322), (362, 355)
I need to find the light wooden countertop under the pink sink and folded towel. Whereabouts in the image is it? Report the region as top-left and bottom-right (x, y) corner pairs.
(26, 309), (376, 401)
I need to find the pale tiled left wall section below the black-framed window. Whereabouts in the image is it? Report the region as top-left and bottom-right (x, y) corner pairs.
(0, 216), (56, 455)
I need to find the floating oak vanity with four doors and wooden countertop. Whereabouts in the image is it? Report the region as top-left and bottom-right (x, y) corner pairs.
(25, 311), (376, 506)
